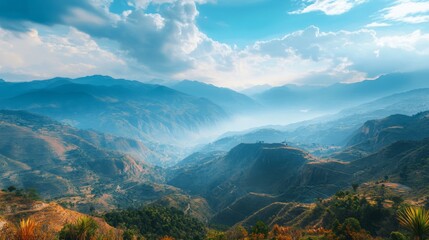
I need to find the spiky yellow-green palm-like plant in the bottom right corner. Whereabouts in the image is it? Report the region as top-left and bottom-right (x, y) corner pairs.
(398, 207), (429, 240)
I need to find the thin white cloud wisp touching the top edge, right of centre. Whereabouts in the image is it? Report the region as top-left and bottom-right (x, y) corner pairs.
(289, 0), (367, 15)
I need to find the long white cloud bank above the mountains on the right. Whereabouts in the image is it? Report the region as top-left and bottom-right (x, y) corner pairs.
(174, 27), (429, 88)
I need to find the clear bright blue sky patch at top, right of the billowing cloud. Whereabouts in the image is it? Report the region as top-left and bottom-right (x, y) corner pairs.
(197, 0), (372, 45)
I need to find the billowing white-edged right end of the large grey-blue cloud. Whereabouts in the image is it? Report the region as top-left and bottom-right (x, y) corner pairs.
(99, 1), (204, 72)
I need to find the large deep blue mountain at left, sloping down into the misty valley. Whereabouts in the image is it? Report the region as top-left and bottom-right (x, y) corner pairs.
(0, 76), (231, 163)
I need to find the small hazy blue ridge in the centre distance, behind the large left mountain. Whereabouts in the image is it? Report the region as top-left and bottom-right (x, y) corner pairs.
(171, 80), (259, 114)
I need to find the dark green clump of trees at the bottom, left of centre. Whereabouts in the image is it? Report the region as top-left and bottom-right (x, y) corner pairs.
(104, 206), (206, 240)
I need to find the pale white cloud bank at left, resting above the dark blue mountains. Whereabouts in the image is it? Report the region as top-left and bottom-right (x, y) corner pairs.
(0, 28), (126, 79)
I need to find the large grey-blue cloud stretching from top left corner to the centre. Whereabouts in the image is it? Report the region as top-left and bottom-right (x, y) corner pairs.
(0, 0), (221, 74)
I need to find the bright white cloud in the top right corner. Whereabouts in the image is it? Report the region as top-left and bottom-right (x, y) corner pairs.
(381, 0), (429, 24)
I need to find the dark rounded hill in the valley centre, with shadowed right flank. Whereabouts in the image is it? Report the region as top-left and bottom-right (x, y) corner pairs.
(168, 143), (315, 210)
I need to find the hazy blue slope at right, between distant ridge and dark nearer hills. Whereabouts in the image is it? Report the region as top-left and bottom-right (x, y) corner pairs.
(285, 88), (429, 146)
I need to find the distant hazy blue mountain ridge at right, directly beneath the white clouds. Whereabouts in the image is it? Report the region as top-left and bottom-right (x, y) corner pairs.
(254, 71), (429, 110)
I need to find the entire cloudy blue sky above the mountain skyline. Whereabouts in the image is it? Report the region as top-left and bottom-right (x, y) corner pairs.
(0, 0), (429, 89)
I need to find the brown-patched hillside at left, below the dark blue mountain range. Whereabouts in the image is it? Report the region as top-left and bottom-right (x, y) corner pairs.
(0, 110), (184, 211)
